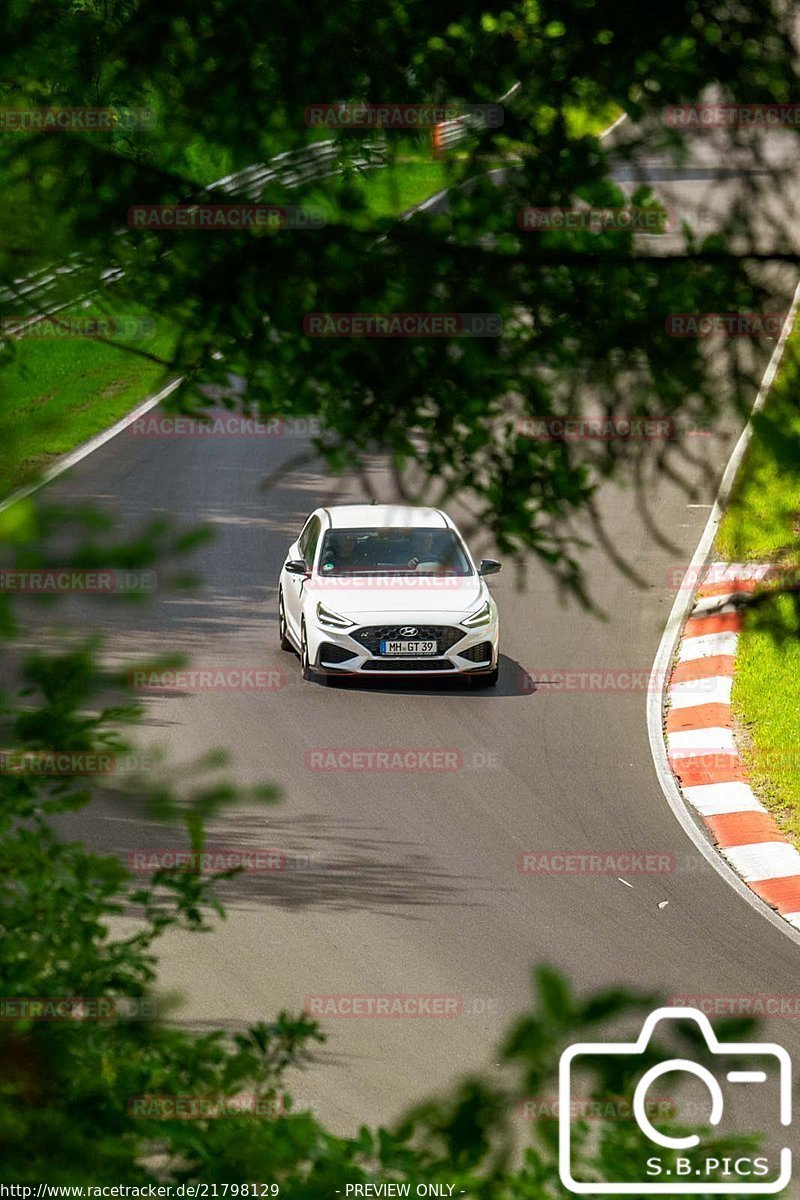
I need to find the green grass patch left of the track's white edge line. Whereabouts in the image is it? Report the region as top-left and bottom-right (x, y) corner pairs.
(0, 298), (175, 498)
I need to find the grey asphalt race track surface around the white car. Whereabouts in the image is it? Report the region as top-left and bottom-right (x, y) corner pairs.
(48, 114), (800, 1132)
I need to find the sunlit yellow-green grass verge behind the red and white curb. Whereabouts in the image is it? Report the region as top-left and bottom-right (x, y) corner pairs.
(717, 334), (800, 846)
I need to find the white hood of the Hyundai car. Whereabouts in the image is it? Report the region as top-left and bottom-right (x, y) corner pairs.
(306, 575), (488, 624)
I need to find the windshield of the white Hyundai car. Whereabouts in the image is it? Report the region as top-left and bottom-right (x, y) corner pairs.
(319, 528), (473, 576)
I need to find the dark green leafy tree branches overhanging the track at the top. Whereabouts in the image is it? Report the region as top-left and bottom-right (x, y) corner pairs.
(0, 0), (794, 590)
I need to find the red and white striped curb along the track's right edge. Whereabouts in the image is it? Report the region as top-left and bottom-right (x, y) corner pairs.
(664, 563), (800, 929)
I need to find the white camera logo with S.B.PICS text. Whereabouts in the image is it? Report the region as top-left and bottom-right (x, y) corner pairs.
(559, 1008), (792, 1196)
